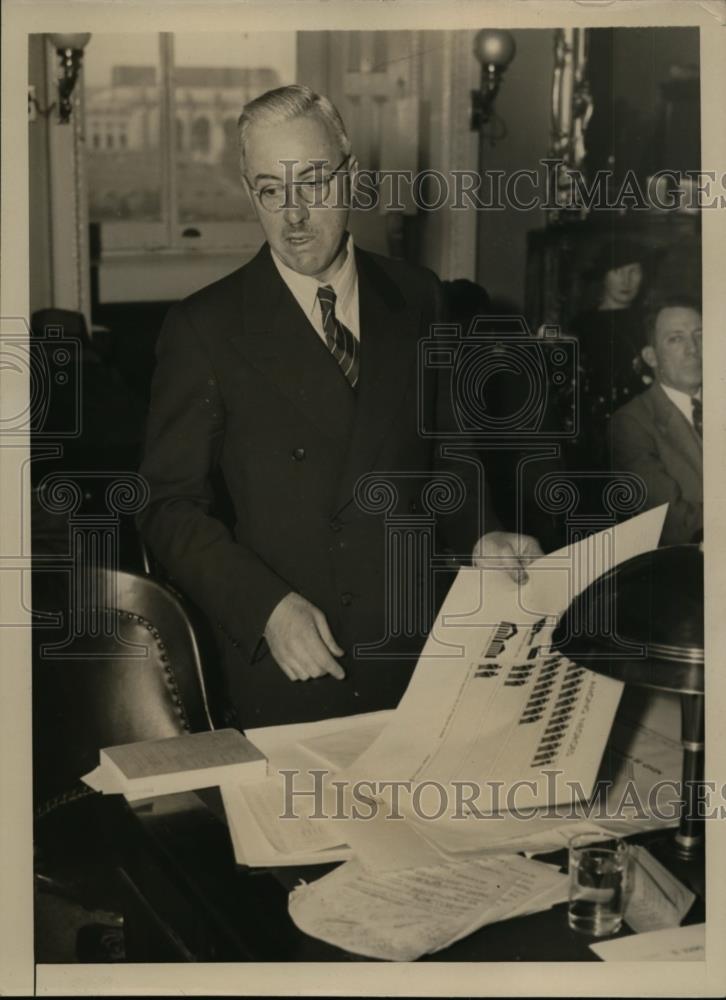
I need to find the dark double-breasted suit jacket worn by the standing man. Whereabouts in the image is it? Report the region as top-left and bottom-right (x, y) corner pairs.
(139, 245), (496, 727)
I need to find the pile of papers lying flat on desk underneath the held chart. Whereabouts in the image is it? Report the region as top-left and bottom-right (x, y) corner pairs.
(222, 692), (682, 871)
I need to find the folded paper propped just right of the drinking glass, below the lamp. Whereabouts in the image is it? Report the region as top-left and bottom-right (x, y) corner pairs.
(625, 845), (696, 933)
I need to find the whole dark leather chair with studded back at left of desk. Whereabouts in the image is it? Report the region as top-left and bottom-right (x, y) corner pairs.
(33, 569), (219, 960)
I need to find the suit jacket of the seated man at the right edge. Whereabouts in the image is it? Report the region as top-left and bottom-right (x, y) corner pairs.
(611, 383), (703, 545)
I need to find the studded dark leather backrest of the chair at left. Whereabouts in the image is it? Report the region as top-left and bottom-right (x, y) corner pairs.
(33, 570), (214, 813)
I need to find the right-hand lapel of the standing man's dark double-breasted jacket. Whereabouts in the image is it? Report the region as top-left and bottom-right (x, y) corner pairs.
(336, 249), (419, 510)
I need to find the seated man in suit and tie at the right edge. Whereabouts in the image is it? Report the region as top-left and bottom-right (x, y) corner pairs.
(611, 297), (703, 545)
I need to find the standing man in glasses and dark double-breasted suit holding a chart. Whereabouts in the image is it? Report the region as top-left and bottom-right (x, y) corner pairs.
(139, 86), (540, 728)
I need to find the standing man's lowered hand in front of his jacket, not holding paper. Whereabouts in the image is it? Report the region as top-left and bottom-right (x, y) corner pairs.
(265, 593), (345, 681)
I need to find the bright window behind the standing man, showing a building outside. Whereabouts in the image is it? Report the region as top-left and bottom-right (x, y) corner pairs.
(84, 32), (296, 256)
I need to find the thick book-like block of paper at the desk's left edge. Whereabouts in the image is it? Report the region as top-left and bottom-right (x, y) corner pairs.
(83, 729), (267, 800)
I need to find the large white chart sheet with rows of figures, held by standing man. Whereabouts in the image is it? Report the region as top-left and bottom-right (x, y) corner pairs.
(346, 505), (666, 812)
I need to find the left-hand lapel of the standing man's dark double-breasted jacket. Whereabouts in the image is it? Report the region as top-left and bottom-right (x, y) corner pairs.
(225, 245), (355, 442)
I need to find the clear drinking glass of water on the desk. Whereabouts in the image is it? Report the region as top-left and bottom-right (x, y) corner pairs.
(567, 833), (630, 937)
